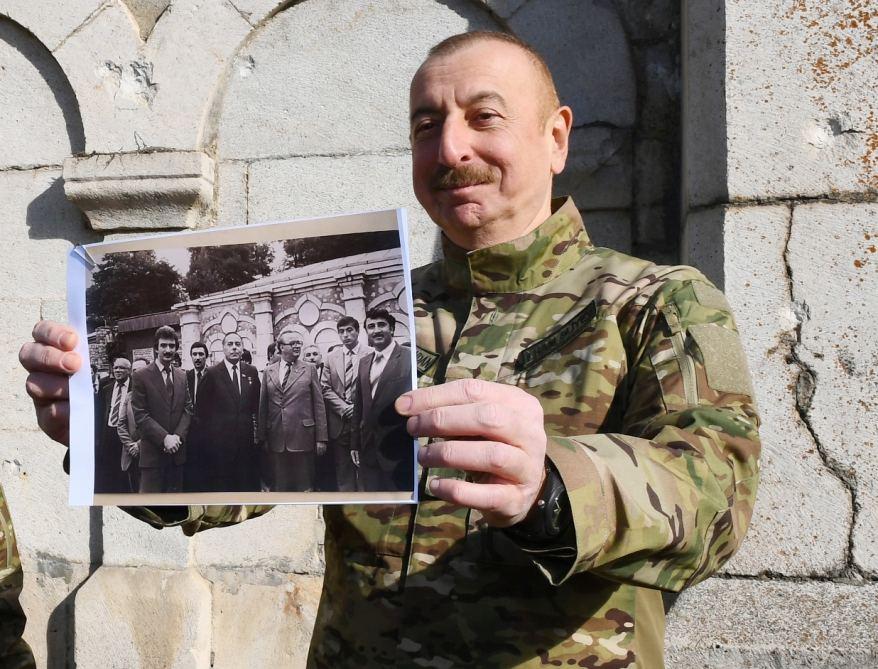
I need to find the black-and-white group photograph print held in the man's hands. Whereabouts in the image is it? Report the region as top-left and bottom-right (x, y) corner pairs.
(70, 211), (415, 505)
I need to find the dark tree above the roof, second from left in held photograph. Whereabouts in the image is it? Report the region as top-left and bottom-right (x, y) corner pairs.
(183, 244), (274, 300)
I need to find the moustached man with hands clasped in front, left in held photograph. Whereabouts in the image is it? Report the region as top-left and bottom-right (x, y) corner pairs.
(131, 325), (192, 493)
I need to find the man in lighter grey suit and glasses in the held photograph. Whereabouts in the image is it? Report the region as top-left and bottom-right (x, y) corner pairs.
(259, 332), (327, 492)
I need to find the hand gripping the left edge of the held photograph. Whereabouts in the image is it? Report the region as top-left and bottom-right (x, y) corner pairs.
(18, 321), (82, 445)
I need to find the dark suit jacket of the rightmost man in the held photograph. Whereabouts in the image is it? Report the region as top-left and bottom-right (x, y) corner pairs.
(351, 344), (414, 472)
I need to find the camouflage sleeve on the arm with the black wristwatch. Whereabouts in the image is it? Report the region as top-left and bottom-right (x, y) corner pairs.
(534, 279), (760, 591)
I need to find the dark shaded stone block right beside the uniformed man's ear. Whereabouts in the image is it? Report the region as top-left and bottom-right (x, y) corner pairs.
(553, 127), (632, 209)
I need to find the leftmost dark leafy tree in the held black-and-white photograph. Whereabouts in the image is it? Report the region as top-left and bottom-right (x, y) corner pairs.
(85, 251), (183, 329)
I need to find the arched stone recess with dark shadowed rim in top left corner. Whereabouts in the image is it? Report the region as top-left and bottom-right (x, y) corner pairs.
(0, 18), (84, 168)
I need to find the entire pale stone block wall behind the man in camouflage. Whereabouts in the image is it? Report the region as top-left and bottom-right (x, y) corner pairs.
(0, 0), (878, 667)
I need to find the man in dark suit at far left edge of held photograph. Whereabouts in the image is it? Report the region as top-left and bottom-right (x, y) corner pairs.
(94, 357), (131, 493)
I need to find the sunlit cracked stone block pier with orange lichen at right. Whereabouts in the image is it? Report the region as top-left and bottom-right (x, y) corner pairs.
(680, 0), (878, 668)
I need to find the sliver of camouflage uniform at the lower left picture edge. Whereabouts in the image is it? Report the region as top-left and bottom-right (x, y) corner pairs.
(0, 489), (36, 669)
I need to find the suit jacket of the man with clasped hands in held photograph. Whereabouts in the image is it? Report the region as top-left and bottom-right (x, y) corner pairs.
(131, 363), (192, 467)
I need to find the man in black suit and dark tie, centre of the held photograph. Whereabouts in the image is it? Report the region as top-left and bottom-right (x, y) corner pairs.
(195, 332), (259, 492)
